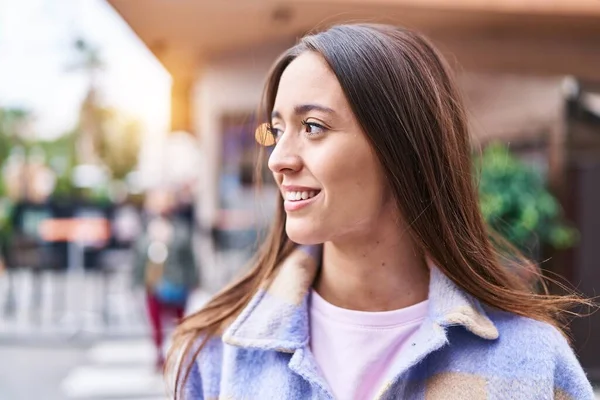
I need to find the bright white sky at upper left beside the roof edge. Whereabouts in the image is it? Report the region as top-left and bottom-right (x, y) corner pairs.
(0, 0), (171, 138)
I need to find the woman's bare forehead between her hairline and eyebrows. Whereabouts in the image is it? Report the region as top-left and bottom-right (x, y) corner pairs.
(274, 52), (346, 112)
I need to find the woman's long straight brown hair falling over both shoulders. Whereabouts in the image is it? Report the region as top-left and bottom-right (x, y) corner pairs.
(170, 24), (583, 394)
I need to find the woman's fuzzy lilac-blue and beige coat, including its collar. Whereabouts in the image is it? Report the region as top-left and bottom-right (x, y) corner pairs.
(180, 252), (594, 400)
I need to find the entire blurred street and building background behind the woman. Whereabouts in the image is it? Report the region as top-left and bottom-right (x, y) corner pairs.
(0, 0), (600, 400)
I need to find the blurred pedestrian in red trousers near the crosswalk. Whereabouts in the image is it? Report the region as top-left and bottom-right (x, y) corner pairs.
(134, 188), (198, 369)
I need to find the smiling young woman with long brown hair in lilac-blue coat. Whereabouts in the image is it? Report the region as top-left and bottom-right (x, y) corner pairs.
(166, 25), (593, 400)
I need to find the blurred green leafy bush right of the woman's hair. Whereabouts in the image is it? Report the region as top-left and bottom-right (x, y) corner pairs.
(475, 143), (578, 256)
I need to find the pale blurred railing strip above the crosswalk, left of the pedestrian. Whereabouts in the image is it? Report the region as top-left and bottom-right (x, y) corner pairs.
(0, 270), (146, 340)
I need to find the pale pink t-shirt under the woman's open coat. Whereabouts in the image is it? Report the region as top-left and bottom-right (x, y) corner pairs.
(310, 290), (427, 400)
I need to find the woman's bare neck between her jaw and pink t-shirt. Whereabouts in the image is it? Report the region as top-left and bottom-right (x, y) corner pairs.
(314, 223), (429, 311)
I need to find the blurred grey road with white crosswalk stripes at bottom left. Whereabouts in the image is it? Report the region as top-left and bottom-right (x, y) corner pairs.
(0, 338), (166, 400)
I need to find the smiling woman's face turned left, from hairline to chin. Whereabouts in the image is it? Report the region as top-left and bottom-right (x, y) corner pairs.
(269, 52), (395, 244)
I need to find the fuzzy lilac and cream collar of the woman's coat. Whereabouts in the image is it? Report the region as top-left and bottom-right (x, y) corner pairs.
(223, 251), (498, 353)
